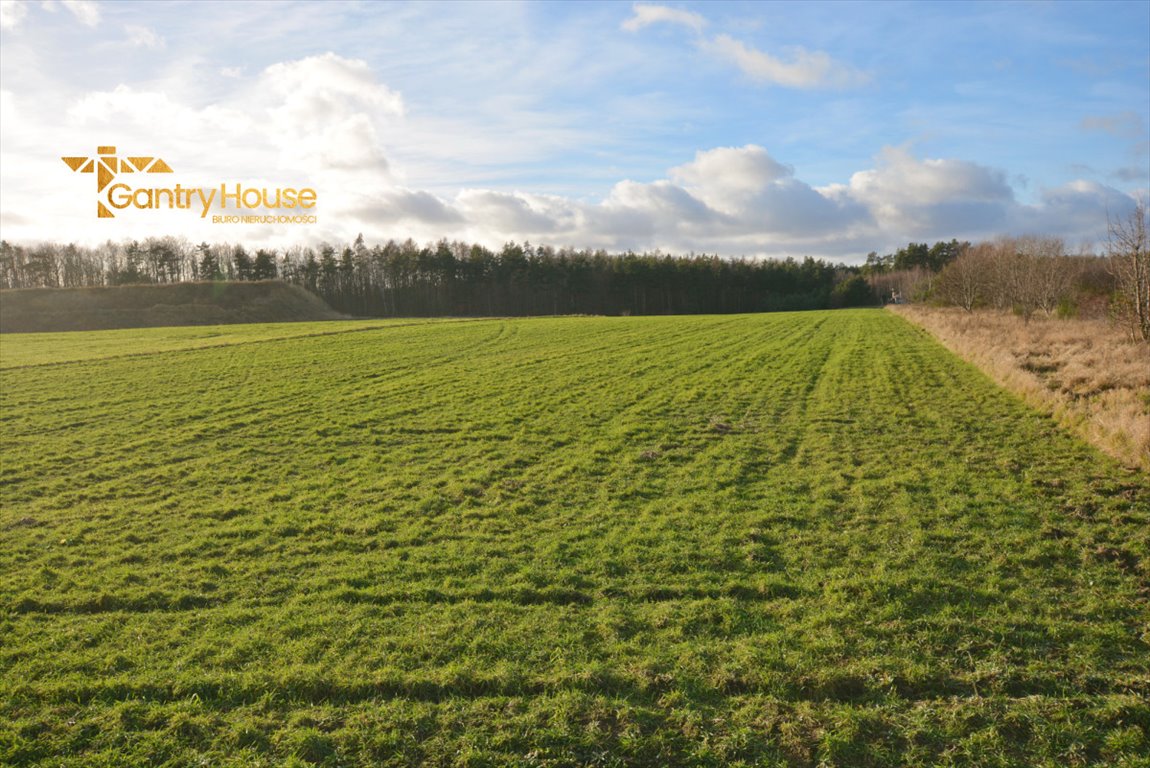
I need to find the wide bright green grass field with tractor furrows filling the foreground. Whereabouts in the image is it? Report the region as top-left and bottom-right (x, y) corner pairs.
(0, 310), (1150, 767)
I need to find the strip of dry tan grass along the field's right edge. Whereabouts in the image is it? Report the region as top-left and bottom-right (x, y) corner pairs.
(891, 305), (1150, 471)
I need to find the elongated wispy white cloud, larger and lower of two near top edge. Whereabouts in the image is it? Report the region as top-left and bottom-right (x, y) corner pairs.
(703, 34), (869, 89)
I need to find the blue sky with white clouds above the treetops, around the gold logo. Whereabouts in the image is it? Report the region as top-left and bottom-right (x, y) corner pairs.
(0, 0), (1150, 263)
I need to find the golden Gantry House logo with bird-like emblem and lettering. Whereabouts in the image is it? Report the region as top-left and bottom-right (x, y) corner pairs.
(61, 146), (317, 224)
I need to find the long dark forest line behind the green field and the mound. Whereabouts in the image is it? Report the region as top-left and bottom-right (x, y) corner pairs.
(0, 236), (876, 317)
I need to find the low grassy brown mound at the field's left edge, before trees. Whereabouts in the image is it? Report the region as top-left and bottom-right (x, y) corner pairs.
(0, 281), (343, 333)
